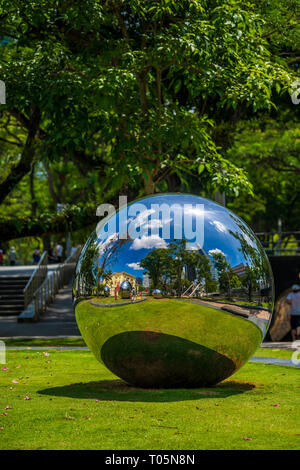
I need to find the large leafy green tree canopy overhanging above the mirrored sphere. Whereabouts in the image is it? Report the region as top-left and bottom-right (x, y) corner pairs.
(0, 0), (298, 241)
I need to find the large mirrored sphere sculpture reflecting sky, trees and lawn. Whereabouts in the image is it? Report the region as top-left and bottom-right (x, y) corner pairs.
(73, 194), (273, 388)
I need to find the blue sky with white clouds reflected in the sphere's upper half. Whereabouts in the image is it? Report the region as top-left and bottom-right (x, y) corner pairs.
(97, 194), (256, 277)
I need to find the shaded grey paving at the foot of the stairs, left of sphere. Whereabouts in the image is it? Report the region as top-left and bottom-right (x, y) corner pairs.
(0, 282), (81, 338)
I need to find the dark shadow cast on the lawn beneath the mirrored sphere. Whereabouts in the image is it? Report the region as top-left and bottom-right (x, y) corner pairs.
(38, 380), (255, 403)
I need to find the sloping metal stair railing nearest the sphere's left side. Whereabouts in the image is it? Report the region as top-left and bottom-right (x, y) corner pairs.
(33, 247), (81, 320)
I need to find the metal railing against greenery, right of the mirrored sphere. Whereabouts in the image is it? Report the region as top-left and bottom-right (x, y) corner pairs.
(256, 231), (300, 255)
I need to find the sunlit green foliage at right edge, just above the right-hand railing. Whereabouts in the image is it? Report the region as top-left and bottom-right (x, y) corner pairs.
(228, 115), (300, 230)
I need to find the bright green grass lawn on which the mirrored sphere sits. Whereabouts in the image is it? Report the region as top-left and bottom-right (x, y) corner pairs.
(0, 349), (300, 450)
